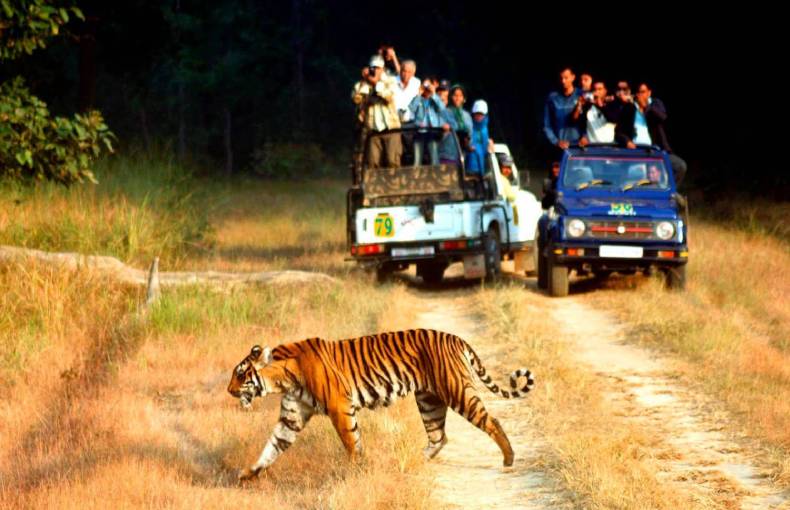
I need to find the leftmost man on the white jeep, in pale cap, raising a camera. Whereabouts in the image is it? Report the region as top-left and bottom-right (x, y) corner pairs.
(351, 55), (403, 168)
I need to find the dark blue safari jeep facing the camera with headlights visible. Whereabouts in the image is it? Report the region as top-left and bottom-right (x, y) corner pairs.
(535, 145), (688, 296)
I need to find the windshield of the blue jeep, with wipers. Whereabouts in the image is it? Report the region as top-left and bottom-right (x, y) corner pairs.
(562, 156), (669, 191)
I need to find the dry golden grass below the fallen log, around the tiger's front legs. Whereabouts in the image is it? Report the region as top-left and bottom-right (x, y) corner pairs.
(0, 262), (430, 508)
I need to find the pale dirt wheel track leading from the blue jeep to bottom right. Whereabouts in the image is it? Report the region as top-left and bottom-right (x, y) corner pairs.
(552, 298), (790, 509)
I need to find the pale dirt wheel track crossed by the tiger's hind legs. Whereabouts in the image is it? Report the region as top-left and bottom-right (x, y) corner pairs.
(414, 292), (569, 509)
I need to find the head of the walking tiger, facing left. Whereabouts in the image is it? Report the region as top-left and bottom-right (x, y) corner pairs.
(228, 345), (298, 410)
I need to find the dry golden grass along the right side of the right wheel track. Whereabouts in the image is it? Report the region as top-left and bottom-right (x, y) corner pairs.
(587, 221), (790, 486)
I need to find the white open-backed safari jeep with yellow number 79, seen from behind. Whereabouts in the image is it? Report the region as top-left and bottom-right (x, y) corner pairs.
(347, 125), (542, 284)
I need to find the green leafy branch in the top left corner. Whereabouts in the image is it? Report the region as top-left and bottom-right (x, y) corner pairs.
(0, 0), (85, 60)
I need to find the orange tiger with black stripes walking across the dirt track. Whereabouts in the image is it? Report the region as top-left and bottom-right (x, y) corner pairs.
(228, 329), (535, 481)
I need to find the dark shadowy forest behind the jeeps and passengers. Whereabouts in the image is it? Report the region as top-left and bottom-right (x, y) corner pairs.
(0, 0), (789, 198)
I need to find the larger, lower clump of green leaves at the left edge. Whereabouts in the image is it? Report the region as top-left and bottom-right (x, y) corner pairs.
(0, 78), (113, 184)
